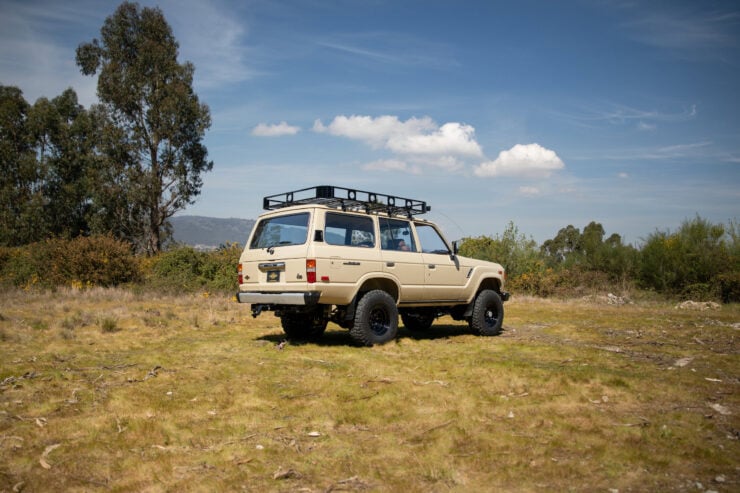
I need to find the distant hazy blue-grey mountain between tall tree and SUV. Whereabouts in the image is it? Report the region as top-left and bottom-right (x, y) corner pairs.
(170, 216), (254, 249)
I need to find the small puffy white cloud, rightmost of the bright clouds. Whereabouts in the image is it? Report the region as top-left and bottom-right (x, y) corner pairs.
(474, 144), (565, 178)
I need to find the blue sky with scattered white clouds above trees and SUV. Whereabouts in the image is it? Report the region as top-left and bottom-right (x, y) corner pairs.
(0, 0), (740, 243)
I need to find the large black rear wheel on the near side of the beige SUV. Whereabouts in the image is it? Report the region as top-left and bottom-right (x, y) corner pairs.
(349, 289), (398, 346)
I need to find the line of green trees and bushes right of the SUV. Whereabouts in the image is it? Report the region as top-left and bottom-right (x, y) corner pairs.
(460, 216), (740, 302)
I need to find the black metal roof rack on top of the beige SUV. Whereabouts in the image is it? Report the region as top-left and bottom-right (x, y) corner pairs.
(262, 185), (432, 218)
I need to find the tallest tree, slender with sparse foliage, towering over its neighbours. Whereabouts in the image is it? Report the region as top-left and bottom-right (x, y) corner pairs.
(77, 2), (213, 254)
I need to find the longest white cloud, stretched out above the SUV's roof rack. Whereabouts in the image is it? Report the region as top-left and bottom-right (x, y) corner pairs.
(313, 115), (483, 157)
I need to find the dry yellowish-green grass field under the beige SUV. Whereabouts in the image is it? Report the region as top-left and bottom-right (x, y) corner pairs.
(0, 289), (740, 492)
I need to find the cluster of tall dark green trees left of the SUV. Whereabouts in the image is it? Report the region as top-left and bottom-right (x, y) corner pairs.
(0, 2), (213, 255)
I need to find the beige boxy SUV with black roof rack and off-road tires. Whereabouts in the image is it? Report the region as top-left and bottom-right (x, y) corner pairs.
(237, 185), (509, 346)
